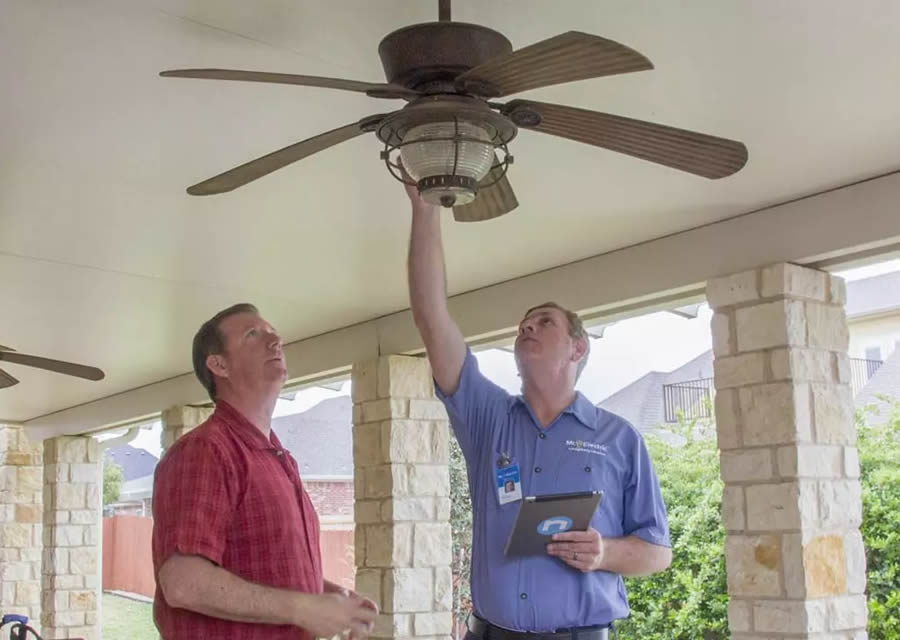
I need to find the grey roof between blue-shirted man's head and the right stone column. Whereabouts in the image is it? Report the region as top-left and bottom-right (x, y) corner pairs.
(597, 351), (713, 432)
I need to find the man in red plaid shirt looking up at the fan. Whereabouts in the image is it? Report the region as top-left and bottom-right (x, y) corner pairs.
(153, 304), (377, 640)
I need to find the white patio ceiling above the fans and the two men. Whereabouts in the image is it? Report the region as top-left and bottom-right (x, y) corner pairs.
(0, 0), (900, 428)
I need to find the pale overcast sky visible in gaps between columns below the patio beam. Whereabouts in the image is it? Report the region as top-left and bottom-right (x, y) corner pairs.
(125, 259), (900, 456)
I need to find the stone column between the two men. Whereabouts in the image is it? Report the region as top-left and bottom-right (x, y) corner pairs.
(353, 356), (453, 638)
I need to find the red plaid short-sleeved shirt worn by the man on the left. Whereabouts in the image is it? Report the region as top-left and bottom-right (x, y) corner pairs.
(153, 401), (323, 640)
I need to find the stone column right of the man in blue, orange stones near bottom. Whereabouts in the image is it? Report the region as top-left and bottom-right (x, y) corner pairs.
(707, 264), (867, 640)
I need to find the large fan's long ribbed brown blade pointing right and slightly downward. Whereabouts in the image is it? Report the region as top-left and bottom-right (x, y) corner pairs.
(503, 100), (747, 180)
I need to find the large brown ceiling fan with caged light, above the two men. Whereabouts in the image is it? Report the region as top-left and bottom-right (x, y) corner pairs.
(160, 0), (747, 222)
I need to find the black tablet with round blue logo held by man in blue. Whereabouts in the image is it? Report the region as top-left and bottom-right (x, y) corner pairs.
(506, 491), (603, 556)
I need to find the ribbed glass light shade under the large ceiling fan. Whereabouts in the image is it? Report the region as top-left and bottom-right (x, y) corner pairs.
(400, 121), (494, 205)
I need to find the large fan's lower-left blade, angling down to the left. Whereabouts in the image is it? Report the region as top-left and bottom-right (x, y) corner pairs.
(187, 116), (383, 196)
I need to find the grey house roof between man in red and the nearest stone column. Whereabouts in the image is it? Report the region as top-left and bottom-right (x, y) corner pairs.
(272, 396), (353, 477)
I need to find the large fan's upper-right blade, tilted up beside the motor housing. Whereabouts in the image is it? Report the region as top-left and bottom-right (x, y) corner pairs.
(456, 31), (653, 97)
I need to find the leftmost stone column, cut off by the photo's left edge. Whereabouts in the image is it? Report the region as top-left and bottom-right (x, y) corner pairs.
(0, 425), (44, 628)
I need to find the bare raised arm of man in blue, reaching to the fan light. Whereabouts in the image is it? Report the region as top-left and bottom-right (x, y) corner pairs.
(406, 186), (466, 395)
